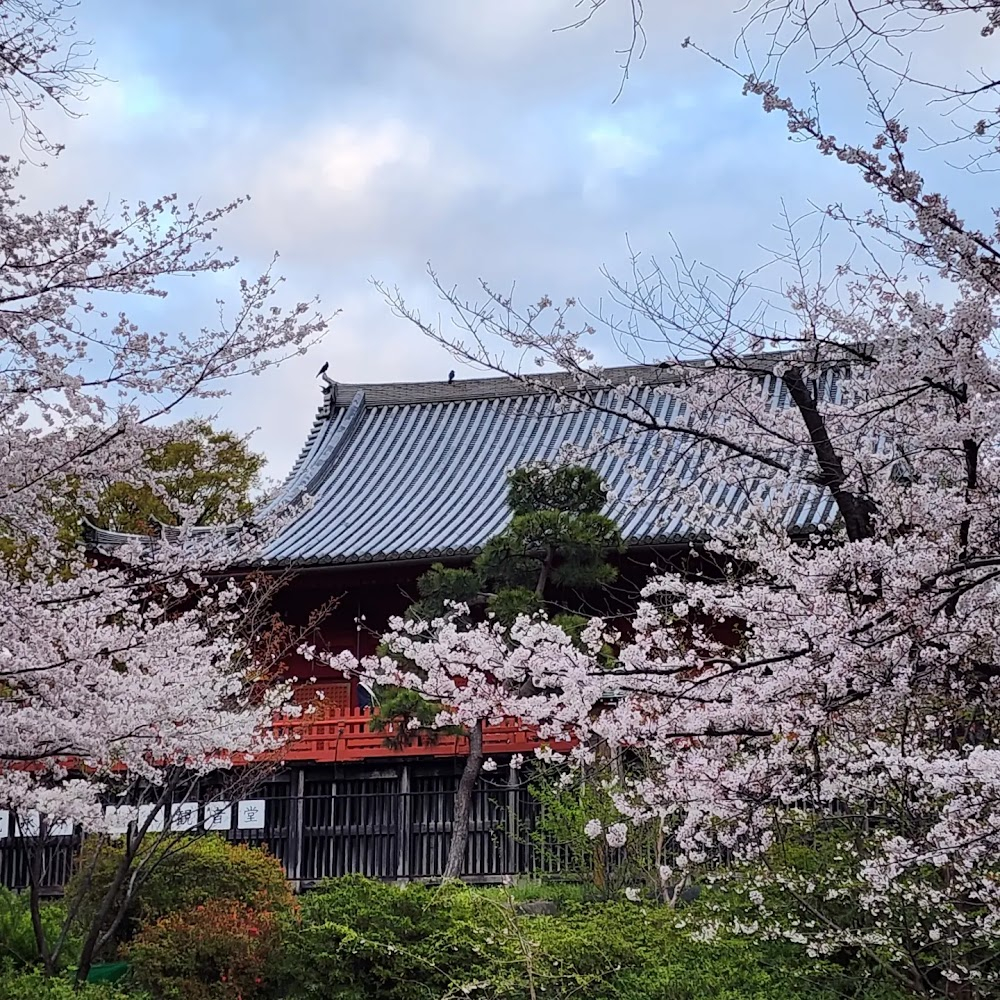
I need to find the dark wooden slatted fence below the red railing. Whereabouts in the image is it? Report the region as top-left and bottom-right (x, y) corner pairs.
(0, 767), (568, 893)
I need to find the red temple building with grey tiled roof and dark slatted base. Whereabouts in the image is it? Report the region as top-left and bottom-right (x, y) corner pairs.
(0, 366), (832, 886)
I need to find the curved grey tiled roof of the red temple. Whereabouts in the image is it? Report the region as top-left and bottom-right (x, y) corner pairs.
(86, 367), (833, 566)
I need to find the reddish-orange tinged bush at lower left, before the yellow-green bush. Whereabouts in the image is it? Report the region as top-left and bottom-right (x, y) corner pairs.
(126, 899), (280, 1000)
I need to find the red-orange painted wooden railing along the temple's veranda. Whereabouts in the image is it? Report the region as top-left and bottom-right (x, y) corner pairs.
(274, 708), (572, 764)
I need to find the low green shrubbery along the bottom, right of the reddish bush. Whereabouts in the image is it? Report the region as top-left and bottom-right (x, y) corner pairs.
(281, 876), (905, 1000)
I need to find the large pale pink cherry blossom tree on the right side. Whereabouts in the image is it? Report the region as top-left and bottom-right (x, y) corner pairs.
(387, 0), (1000, 997)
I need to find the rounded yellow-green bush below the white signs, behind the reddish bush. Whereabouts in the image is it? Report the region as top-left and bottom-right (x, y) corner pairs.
(66, 834), (293, 939)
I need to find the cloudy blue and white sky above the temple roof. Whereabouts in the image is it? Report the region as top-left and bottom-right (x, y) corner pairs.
(13, 0), (984, 484)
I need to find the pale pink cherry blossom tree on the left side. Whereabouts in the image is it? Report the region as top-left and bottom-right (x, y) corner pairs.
(0, 0), (327, 975)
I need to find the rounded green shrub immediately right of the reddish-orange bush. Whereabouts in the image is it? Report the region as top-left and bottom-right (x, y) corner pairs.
(283, 876), (509, 1000)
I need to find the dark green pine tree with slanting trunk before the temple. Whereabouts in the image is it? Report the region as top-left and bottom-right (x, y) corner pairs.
(362, 466), (621, 878)
